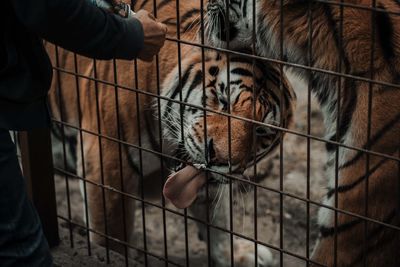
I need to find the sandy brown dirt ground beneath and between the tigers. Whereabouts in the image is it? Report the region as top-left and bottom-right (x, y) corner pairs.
(53, 76), (326, 267)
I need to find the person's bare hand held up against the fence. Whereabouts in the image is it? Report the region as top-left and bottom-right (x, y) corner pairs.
(133, 10), (167, 61)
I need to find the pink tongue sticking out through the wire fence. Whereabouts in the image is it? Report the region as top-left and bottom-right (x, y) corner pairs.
(163, 166), (207, 209)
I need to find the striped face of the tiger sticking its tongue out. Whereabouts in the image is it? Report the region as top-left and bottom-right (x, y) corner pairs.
(161, 51), (294, 178)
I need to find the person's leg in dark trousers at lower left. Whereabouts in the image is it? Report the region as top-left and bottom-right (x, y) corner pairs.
(0, 129), (52, 267)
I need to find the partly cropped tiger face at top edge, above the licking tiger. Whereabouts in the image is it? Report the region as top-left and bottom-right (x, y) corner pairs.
(205, 0), (256, 50)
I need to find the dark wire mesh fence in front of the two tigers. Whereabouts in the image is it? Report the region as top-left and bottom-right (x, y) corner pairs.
(19, 0), (400, 266)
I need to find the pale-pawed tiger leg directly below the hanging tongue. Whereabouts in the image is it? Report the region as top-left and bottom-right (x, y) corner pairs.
(190, 184), (273, 267)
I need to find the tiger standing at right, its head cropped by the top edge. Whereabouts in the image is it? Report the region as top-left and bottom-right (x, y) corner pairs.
(206, 0), (400, 266)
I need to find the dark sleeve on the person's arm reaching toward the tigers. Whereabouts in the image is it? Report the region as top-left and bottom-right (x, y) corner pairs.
(11, 0), (144, 59)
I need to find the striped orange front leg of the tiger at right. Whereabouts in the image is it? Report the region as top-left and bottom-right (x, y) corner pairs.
(313, 97), (400, 266)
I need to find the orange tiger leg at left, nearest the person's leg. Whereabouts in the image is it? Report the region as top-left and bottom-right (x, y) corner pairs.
(77, 133), (138, 254)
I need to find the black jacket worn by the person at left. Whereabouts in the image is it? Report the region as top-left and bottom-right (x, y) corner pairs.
(0, 0), (143, 130)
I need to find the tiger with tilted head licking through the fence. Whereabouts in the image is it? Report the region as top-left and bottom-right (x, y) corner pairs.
(46, 0), (296, 266)
